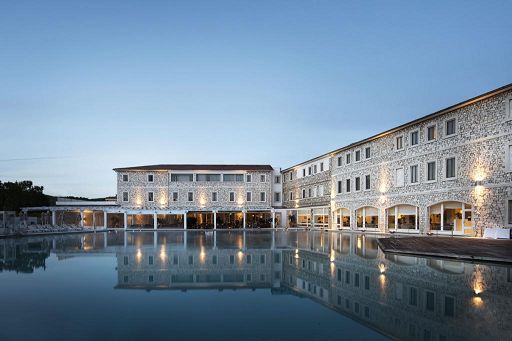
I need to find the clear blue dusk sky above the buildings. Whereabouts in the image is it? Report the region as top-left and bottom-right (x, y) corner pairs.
(0, 0), (512, 196)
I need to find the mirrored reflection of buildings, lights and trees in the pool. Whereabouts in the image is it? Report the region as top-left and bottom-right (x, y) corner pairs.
(0, 231), (512, 340)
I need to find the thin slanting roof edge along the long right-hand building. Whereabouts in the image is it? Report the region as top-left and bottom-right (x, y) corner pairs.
(283, 83), (512, 172)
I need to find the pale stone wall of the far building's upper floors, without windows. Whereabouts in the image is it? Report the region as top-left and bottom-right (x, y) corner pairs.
(117, 171), (273, 211)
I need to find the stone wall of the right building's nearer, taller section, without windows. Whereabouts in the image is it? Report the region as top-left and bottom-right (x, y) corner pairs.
(332, 87), (512, 235)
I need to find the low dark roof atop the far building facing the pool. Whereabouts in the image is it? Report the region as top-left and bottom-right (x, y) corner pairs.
(114, 164), (274, 172)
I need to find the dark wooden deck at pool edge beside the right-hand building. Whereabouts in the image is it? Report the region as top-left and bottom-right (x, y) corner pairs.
(378, 237), (512, 263)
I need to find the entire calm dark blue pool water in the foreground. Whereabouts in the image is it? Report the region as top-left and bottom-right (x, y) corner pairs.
(0, 231), (512, 340)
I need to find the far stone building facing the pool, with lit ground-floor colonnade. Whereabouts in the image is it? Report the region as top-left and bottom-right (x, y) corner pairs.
(114, 165), (281, 228)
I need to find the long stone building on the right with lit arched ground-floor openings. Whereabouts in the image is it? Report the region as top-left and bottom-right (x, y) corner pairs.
(283, 85), (512, 236)
